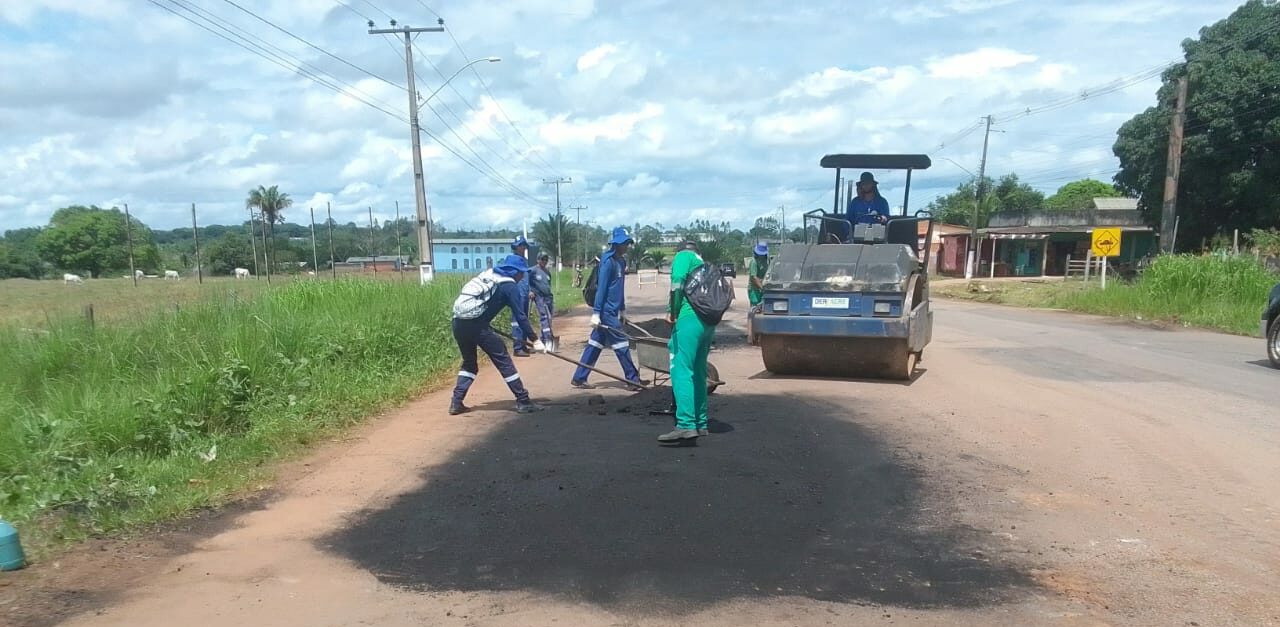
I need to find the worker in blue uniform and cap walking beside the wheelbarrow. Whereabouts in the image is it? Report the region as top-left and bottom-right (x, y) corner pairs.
(570, 226), (643, 389)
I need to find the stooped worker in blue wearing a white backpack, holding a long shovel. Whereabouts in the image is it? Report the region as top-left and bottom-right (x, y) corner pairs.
(449, 255), (544, 416)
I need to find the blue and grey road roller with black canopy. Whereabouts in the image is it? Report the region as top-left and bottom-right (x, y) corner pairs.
(750, 154), (933, 380)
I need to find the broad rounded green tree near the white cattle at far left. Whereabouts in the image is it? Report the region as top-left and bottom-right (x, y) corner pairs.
(36, 206), (160, 276)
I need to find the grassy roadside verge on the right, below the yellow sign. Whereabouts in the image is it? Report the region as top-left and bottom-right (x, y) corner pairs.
(934, 255), (1280, 335)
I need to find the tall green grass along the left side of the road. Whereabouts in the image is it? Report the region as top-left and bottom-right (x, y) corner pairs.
(0, 269), (577, 555)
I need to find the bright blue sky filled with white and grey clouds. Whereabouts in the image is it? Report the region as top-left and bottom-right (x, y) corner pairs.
(0, 0), (1239, 230)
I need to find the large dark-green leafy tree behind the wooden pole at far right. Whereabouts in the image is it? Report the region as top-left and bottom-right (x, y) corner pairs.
(1112, 0), (1280, 248)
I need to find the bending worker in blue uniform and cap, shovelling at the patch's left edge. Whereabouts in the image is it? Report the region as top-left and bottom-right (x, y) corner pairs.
(449, 255), (543, 416)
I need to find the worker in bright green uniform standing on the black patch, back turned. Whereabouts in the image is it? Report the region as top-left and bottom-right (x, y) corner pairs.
(658, 242), (716, 444)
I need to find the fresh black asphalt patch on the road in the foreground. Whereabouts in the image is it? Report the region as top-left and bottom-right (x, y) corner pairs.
(320, 388), (1034, 613)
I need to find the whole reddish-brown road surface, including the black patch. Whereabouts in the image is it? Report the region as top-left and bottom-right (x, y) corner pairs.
(0, 276), (1280, 627)
